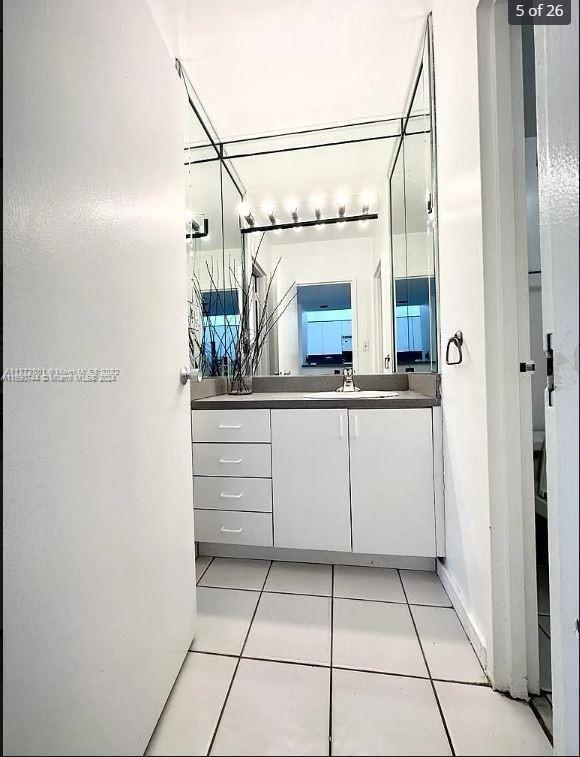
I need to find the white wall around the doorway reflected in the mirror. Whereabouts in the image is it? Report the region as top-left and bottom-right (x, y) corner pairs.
(271, 236), (374, 376)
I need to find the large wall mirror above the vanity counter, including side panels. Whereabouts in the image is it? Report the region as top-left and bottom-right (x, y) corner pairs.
(180, 16), (438, 384)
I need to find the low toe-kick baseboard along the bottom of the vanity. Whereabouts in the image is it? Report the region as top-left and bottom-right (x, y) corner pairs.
(198, 542), (435, 571)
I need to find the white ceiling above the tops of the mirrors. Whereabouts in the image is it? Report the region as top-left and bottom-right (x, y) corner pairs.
(149, 0), (431, 140)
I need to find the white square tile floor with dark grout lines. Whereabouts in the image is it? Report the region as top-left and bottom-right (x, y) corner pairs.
(146, 557), (552, 755)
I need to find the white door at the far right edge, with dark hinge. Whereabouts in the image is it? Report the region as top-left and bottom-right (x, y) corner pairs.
(534, 14), (579, 755)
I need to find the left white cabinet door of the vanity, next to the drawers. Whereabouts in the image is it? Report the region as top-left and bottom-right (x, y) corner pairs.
(272, 409), (351, 552)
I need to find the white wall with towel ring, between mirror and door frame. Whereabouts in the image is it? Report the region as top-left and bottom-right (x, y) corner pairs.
(433, 0), (492, 660)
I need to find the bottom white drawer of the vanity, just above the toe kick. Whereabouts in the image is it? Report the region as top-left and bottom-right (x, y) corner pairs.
(194, 510), (273, 547)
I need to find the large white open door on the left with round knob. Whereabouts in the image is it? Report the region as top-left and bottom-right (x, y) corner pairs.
(3, 0), (195, 755)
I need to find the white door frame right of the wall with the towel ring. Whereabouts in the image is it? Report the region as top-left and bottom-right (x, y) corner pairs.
(477, 0), (539, 699)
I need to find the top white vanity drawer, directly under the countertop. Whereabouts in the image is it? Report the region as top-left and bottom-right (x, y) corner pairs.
(192, 410), (270, 442)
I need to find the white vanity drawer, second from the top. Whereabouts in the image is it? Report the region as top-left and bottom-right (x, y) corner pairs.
(193, 442), (272, 478)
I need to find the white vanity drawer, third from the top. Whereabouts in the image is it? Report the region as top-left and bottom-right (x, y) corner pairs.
(193, 476), (272, 513)
